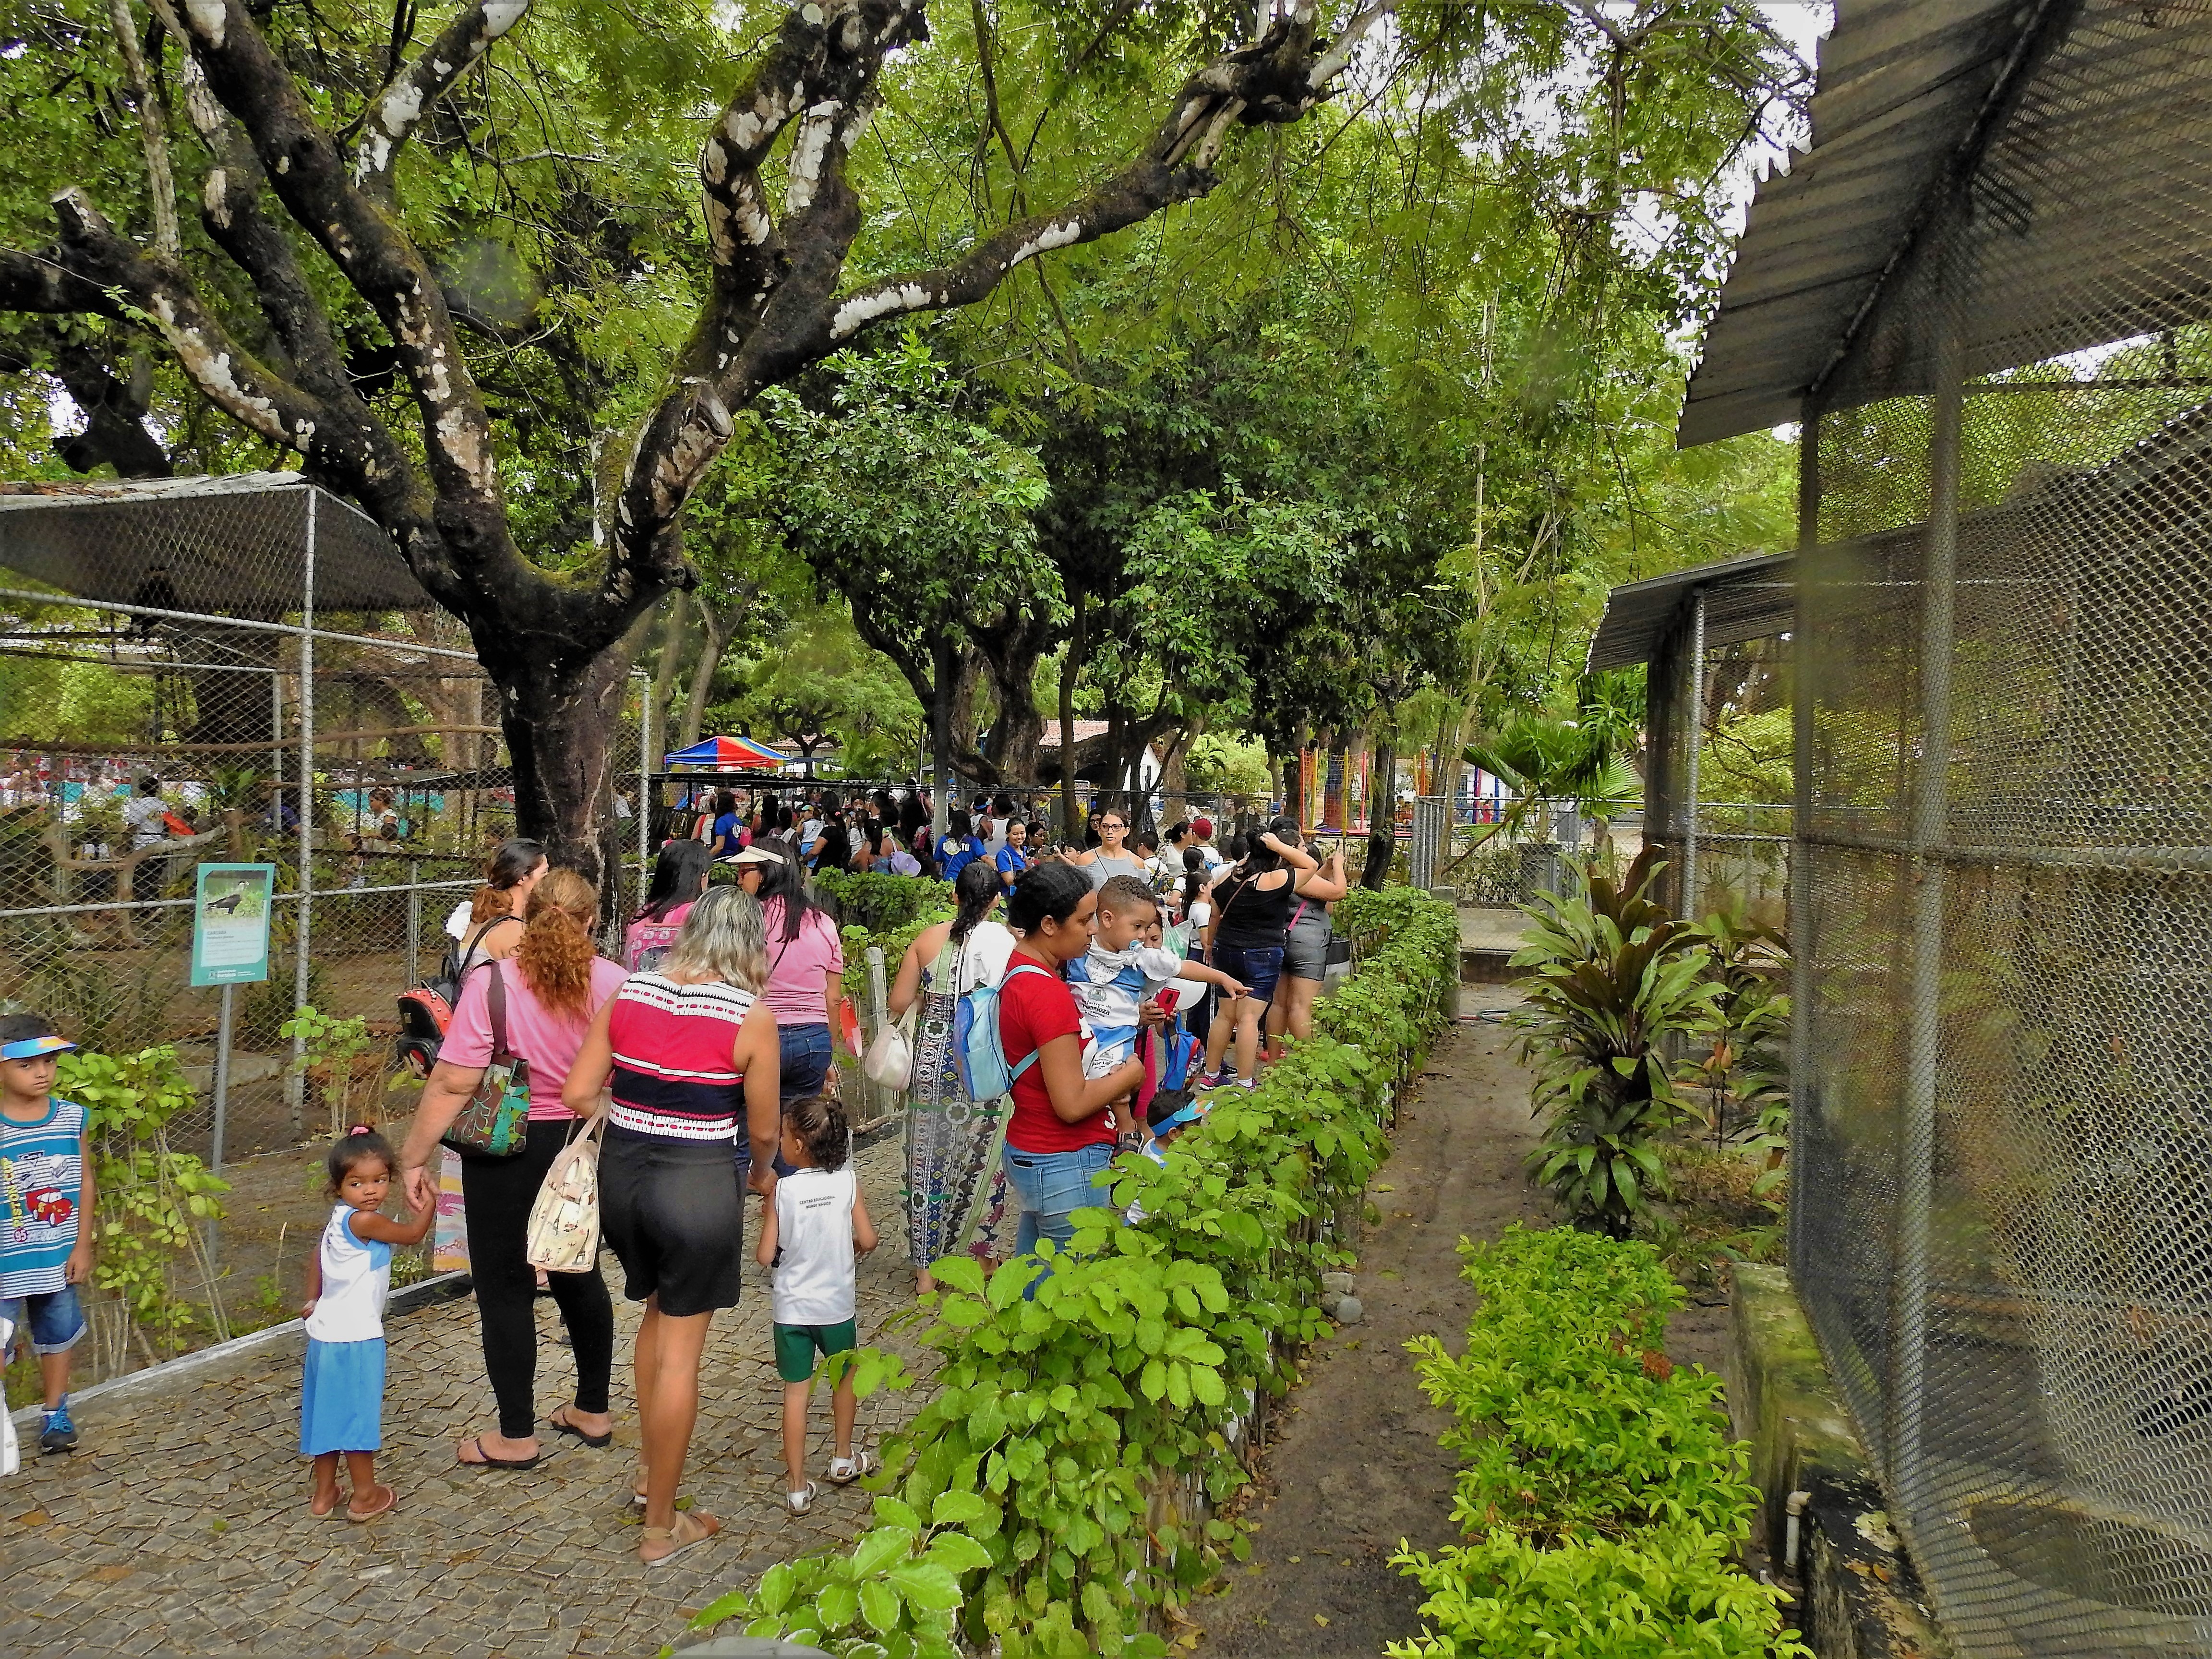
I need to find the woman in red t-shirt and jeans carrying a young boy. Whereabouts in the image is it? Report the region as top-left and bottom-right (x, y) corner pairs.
(998, 865), (1143, 1254)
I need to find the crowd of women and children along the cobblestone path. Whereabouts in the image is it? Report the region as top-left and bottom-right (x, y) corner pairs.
(0, 796), (1345, 1566)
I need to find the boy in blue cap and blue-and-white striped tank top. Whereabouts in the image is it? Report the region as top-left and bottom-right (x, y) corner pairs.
(0, 1013), (93, 1451)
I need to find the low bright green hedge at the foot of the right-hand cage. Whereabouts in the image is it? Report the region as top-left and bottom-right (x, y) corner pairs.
(1389, 1226), (1809, 1659)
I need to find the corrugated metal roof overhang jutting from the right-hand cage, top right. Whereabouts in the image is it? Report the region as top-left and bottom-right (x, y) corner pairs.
(1677, 0), (2035, 447)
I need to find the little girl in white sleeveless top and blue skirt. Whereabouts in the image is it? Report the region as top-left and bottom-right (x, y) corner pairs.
(299, 1124), (438, 1522)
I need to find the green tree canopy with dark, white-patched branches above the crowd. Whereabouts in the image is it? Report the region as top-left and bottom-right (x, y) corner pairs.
(0, 0), (1807, 845)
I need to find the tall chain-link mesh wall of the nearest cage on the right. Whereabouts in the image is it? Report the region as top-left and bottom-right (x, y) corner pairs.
(1791, 4), (2212, 1659)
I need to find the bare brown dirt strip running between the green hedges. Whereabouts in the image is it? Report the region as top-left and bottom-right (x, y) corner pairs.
(1192, 985), (1728, 1659)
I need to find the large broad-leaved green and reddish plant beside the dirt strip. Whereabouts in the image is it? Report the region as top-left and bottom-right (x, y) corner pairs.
(1509, 849), (1721, 1238)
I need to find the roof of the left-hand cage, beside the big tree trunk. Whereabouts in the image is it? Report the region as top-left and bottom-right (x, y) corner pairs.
(0, 471), (432, 622)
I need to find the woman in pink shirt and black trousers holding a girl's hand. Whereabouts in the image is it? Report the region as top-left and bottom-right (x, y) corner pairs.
(400, 869), (624, 1469)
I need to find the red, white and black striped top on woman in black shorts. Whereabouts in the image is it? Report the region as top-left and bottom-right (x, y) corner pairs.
(606, 974), (754, 1142)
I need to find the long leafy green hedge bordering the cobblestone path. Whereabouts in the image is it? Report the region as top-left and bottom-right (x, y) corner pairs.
(695, 889), (1458, 1659)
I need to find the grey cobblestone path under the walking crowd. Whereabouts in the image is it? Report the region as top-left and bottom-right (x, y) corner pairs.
(0, 1132), (925, 1659)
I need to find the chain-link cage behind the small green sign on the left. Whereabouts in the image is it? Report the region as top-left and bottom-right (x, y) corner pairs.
(0, 473), (646, 1159)
